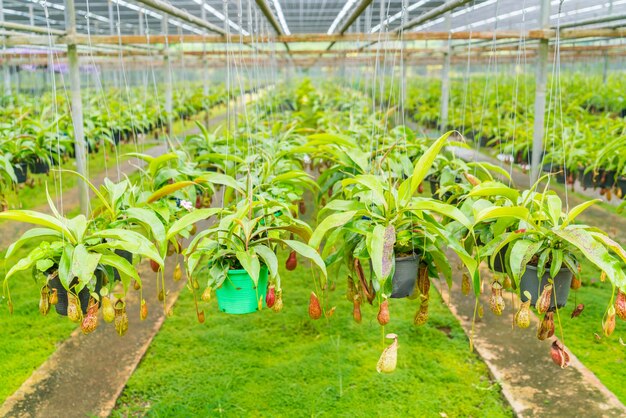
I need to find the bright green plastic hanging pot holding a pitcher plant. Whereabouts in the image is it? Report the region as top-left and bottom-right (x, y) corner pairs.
(215, 266), (267, 315)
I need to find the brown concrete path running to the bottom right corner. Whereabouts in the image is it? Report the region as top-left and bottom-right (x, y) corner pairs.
(438, 266), (626, 418)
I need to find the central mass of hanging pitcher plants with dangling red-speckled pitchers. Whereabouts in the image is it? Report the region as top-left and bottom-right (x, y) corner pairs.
(0, 82), (626, 371)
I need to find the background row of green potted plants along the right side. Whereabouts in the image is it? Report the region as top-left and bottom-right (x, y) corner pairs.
(370, 73), (626, 207)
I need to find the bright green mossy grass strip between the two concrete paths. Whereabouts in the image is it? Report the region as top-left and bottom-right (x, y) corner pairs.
(113, 256), (512, 417)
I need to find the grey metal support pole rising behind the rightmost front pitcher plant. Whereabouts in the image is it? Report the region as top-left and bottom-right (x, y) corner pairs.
(530, 0), (550, 183)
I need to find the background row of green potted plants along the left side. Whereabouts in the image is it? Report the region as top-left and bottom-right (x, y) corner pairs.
(0, 86), (227, 209)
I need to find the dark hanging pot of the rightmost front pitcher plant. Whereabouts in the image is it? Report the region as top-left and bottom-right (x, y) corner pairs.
(520, 265), (573, 310)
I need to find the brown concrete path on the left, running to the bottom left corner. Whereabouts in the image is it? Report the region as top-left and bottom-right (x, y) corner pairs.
(0, 103), (234, 418)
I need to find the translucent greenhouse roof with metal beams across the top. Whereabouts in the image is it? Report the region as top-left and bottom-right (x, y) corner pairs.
(1, 0), (626, 35)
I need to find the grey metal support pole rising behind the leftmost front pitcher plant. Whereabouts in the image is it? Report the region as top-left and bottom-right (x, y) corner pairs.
(65, 0), (89, 215)
